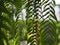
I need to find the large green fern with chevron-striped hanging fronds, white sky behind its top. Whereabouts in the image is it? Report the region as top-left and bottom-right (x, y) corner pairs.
(26, 0), (57, 45)
